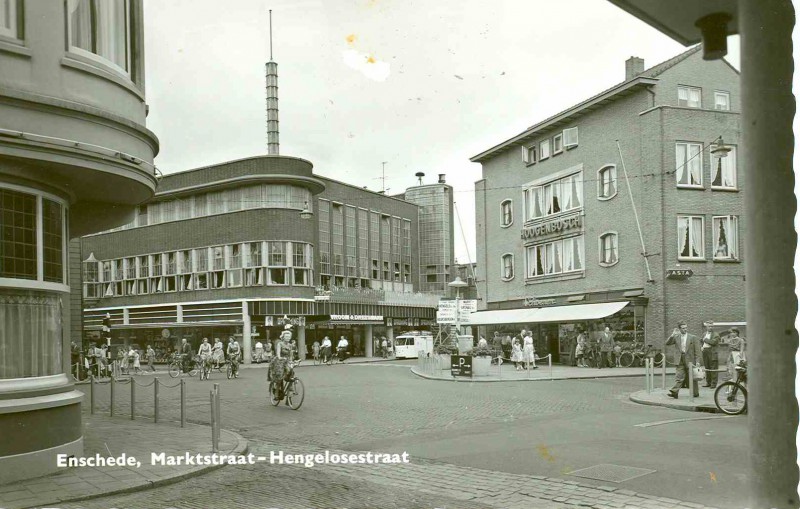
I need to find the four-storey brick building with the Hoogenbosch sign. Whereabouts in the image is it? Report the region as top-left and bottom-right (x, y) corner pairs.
(471, 46), (746, 362)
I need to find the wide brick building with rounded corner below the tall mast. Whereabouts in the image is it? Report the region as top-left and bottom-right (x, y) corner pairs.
(81, 155), (435, 362)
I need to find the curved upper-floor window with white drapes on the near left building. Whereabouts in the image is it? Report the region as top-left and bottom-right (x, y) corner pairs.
(67, 0), (131, 74)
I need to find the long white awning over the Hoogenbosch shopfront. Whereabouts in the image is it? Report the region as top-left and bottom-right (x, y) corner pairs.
(469, 301), (628, 325)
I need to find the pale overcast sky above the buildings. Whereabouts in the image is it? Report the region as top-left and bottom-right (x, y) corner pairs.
(145, 0), (739, 262)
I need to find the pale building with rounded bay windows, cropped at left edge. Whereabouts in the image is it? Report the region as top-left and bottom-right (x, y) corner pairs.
(0, 0), (158, 484)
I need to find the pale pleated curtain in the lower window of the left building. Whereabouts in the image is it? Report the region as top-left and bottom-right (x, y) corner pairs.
(0, 289), (63, 378)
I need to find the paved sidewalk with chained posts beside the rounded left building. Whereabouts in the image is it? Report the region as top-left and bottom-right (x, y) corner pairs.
(0, 414), (247, 509)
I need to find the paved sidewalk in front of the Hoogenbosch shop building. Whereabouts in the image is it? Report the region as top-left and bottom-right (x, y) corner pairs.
(411, 362), (675, 380)
